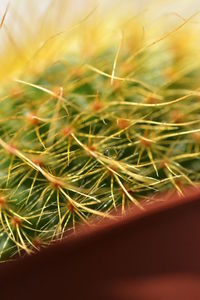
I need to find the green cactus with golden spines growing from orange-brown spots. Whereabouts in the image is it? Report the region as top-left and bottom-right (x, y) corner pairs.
(0, 6), (200, 260)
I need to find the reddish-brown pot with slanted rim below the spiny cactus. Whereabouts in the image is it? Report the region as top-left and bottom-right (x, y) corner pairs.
(0, 187), (200, 300)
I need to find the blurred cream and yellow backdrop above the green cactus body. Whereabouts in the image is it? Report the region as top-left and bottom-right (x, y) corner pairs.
(0, 0), (200, 83)
